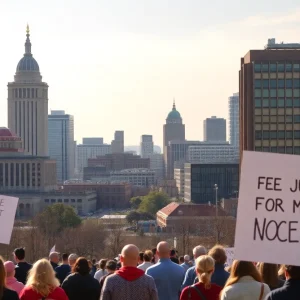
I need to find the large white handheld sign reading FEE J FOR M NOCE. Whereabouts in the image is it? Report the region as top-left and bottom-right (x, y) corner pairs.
(234, 151), (300, 265)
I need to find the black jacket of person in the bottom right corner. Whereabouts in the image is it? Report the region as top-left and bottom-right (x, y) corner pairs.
(266, 279), (300, 300)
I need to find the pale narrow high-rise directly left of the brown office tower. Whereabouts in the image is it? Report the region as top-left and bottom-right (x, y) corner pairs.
(228, 93), (240, 147)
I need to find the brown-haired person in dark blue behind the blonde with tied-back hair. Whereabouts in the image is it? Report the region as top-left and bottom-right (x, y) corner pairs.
(208, 245), (229, 288)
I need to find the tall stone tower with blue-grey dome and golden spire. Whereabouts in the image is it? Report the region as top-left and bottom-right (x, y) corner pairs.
(7, 26), (48, 156)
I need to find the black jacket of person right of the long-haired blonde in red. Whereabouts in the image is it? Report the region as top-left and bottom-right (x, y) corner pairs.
(61, 273), (100, 300)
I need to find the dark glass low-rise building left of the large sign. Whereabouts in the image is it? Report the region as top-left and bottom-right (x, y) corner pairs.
(184, 163), (239, 204)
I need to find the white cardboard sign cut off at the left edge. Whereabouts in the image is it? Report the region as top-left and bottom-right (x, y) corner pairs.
(0, 195), (19, 245)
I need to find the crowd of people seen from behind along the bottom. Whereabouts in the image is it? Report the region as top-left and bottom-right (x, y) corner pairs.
(0, 241), (300, 300)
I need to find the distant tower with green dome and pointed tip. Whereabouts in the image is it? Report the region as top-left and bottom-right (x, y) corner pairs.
(163, 101), (185, 179)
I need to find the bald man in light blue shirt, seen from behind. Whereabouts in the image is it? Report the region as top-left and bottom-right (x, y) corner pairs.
(146, 242), (185, 300)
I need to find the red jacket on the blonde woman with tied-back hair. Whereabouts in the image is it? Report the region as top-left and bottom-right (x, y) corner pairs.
(180, 282), (222, 300)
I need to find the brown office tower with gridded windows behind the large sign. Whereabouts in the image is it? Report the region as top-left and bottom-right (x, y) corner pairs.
(240, 39), (300, 162)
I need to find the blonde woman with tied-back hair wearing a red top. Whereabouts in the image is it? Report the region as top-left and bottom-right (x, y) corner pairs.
(180, 255), (222, 300)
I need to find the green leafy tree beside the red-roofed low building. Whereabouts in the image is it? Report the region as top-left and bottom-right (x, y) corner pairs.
(139, 191), (170, 215)
